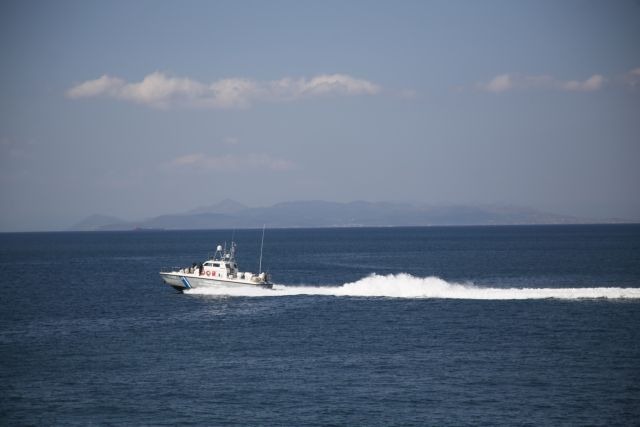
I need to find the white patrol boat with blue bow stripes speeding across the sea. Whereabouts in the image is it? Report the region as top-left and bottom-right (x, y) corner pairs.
(160, 242), (273, 292)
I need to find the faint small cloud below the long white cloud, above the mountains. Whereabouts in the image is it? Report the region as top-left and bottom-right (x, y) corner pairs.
(171, 153), (294, 172)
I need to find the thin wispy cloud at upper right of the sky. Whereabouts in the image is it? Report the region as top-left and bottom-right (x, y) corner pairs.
(476, 74), (606, 93)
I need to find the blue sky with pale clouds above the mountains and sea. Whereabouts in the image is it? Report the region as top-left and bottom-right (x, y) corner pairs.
(0, 0), (640, 231)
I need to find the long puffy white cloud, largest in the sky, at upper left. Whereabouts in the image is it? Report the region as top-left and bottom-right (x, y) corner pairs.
(66, 72), (381, 109)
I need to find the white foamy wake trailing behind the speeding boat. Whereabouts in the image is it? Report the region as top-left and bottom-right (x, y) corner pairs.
(186, 273), (640, 300)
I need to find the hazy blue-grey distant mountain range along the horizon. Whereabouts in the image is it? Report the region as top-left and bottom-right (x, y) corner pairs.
(71, 199), (595, 231)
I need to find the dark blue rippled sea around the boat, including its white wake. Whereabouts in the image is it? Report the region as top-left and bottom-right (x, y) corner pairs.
(0, 225), (640, 426)
